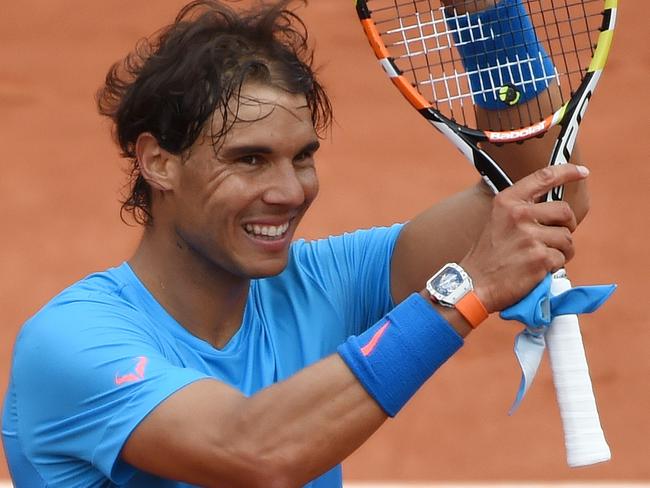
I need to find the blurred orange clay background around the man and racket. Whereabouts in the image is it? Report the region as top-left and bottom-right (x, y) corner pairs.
(0, 0), (650, 484)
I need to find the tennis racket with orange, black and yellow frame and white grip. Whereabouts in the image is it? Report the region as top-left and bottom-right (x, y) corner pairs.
(356, 0), (617, 467)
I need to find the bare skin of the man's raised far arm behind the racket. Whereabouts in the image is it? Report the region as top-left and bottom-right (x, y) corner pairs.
(391, 0), (589, 302)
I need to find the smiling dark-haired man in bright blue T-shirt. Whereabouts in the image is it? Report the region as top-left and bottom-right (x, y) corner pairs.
(3, 1), (587, 488)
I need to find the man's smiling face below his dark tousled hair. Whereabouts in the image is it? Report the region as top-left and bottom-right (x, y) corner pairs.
(154, 84), (319, 278)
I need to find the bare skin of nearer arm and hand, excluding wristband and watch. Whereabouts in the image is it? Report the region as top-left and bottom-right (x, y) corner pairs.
(122, 165), (585, 488)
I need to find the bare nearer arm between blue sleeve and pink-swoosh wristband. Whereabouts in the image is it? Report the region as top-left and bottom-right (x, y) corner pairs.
(122, 356), (386, 488)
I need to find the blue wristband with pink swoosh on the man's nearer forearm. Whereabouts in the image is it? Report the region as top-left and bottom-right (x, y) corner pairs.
(338, 293), (463, 417)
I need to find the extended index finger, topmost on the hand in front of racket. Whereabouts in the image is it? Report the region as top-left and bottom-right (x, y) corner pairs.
(503, 163), (589, 202)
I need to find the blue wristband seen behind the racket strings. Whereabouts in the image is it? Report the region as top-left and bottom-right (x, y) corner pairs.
(447, 0), (556, 110)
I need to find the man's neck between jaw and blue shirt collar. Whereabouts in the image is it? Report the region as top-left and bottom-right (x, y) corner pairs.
(129, 223), (250, 348)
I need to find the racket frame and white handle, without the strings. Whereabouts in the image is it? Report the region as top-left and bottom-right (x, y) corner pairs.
(356, 0), (618, 467)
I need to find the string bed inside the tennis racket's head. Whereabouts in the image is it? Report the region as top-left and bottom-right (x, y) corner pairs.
(368, 0), (602, 130)
